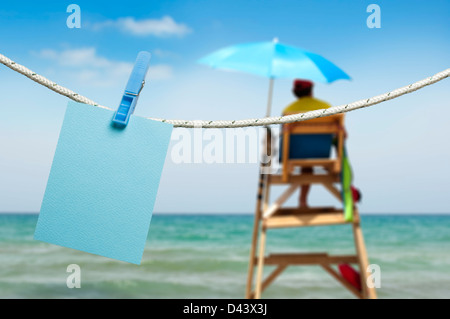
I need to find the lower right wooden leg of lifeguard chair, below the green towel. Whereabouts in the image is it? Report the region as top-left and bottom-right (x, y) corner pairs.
(353, 216), (377, 299)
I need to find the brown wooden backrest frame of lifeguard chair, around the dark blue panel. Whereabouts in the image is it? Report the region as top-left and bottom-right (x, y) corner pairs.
(281, 114), (344, 182)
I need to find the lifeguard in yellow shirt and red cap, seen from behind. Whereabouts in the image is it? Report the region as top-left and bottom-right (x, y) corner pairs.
(283, 80), (331, 208)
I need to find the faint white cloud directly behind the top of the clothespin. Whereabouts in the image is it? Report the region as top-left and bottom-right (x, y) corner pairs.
(38, 47), (173, 87)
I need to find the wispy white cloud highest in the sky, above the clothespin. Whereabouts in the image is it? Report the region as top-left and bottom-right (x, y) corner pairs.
(93, 16), (192, 37)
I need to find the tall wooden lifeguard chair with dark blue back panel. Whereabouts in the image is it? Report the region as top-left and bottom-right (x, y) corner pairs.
(246, 114), (376, 299)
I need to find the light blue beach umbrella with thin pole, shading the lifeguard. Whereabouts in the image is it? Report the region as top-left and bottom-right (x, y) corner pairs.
(198, 38), (350, 116)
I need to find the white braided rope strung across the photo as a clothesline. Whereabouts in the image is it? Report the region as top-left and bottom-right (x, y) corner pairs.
(0, 54), (450, 128)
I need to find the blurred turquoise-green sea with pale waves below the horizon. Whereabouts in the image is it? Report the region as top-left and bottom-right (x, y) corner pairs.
(0, 214), (450, 299)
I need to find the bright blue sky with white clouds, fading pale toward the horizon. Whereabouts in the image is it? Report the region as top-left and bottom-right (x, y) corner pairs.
(0, 0), (450, 213)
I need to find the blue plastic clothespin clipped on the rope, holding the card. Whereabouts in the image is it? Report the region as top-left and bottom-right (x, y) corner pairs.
(112, 51), (151, 128)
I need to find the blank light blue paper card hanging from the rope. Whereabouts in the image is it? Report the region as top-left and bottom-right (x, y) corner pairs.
(34, 101), (172, 264)
